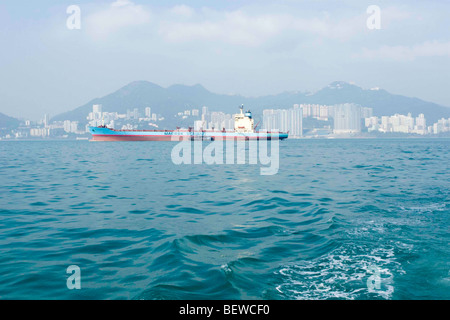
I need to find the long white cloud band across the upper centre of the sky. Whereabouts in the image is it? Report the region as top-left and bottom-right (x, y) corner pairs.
(158, 6), (365, 47)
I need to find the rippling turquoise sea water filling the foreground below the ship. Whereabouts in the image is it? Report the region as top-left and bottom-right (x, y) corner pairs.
(0, 139), (450, 300)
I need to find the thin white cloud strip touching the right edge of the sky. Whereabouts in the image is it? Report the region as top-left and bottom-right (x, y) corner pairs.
(355, 40), (450, 61)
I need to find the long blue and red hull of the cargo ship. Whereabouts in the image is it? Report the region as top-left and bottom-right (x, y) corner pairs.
(89, 127), (288, 141)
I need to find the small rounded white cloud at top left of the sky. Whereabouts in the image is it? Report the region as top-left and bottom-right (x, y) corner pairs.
(86, 0), (151, 38)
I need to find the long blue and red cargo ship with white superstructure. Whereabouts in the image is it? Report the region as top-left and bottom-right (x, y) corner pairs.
(89, 106), (289, 141)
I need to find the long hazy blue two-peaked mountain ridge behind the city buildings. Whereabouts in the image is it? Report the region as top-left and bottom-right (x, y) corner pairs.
(52, 81), (450, 123)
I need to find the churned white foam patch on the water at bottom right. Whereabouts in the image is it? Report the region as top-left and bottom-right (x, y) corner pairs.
(276, 245), (403, 300)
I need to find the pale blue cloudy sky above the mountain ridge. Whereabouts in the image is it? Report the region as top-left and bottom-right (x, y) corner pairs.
(0, 0), (450, 120)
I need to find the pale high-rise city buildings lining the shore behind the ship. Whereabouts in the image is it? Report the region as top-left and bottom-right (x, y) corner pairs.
(4, 103), (450, 140)
